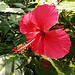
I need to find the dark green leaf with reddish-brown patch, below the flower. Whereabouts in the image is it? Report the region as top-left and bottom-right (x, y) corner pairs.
(35, 58), (58, 75)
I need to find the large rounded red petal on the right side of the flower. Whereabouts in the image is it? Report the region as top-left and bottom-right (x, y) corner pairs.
(44, 29), (71, 59)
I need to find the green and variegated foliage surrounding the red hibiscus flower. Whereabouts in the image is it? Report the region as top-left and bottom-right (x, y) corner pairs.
(0, 0), (75, 75)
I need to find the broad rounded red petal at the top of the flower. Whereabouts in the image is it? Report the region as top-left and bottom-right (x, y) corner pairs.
(31, 4), (58, 32)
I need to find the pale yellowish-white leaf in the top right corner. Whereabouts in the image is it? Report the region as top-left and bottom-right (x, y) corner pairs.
(56, 1), (75, 11)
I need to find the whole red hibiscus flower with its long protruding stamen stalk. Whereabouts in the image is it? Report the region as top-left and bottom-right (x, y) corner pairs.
(14, 4), (71, 59)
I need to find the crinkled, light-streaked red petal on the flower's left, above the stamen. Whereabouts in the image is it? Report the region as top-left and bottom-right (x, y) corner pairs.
(19, 12), (37, 37)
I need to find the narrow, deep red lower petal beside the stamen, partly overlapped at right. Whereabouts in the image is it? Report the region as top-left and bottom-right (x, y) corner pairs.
(30, 33), (44, 55)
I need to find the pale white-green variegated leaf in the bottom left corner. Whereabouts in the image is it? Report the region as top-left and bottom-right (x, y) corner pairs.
(0, 54), (24, 75)
